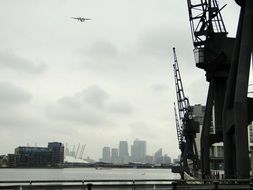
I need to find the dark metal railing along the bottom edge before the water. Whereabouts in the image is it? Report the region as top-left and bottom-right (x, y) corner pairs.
(0, 179), (253, 190)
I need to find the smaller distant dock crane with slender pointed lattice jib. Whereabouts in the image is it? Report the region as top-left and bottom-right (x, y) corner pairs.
(173, 48), (199, 175)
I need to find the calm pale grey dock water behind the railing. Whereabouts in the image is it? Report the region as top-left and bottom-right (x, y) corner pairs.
(0, 168), (179, 180)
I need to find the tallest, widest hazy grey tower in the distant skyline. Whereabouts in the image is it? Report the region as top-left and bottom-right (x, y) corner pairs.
(131, 139), (147, 162)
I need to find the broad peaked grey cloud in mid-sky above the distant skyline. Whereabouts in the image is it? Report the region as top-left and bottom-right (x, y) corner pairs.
(46, 85), (132, 127)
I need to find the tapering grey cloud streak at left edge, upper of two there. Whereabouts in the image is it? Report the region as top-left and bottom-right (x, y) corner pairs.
(0, 51), (46, 74)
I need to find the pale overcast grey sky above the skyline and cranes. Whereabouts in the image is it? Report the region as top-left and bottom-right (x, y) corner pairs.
(0, 0), (239, 160)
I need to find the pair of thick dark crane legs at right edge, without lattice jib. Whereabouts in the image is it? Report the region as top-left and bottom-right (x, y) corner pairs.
(223, 0), (253, 179)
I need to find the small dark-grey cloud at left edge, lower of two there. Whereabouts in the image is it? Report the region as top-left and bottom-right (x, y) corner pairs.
(0, 82), (32, 105)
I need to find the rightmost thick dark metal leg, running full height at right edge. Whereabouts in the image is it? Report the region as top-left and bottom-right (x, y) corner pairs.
(234, 0), (253, 178)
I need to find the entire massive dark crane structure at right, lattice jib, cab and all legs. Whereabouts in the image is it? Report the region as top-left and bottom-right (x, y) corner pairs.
(184, 0), (253, 179)
